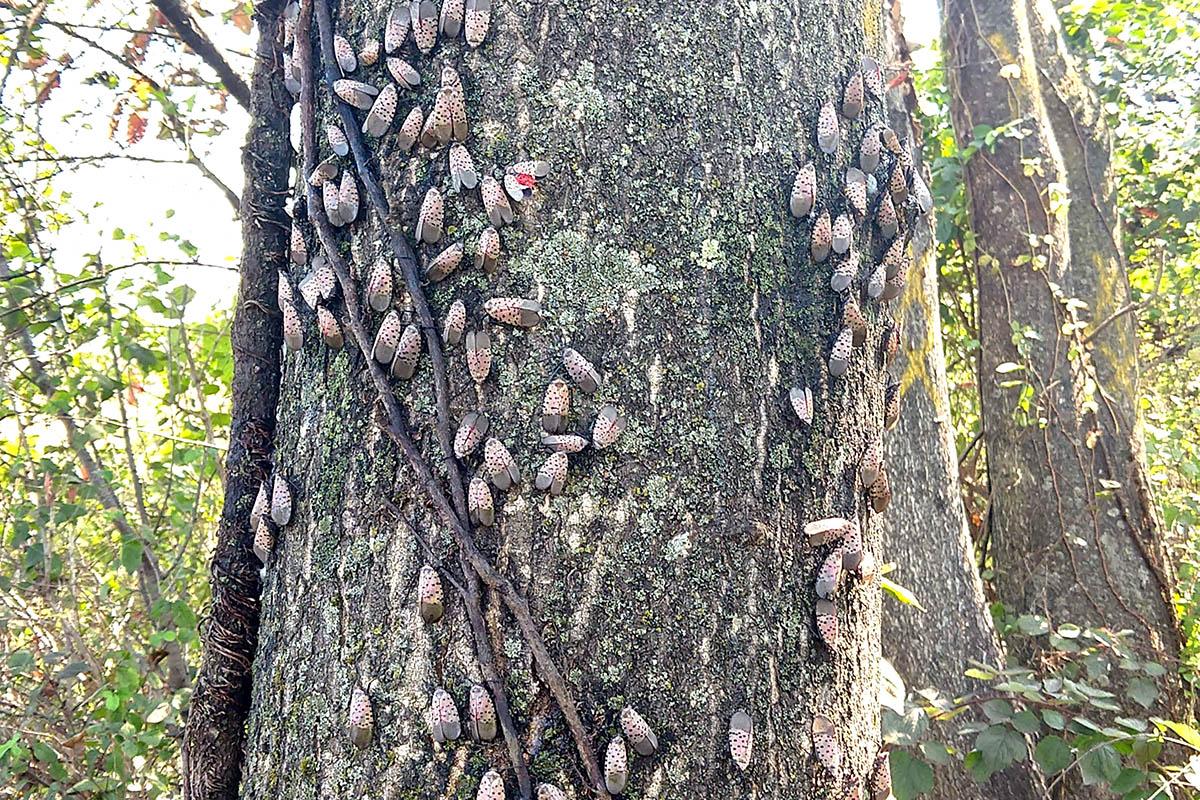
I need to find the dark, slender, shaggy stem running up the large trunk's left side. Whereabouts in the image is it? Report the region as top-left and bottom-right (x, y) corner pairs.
(184, 0), (292, 800)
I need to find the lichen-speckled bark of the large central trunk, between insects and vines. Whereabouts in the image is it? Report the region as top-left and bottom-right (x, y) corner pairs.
(242, 0), (902, 798)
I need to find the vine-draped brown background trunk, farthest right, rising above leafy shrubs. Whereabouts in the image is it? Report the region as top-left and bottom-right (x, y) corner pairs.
(946, 0), (1180, 710)
